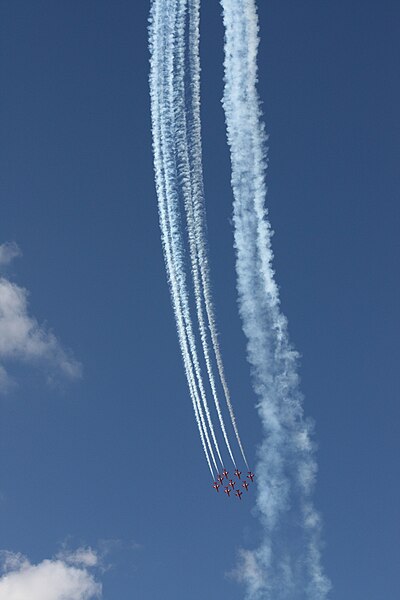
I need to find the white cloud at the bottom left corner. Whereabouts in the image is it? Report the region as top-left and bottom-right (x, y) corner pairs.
(0, 549), (102, 600)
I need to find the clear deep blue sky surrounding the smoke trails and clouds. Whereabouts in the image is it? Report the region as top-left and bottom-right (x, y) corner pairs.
(0, 0), (400, 600)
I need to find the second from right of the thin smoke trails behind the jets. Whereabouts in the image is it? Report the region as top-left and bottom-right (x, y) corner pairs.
(174, 0), (236, 467)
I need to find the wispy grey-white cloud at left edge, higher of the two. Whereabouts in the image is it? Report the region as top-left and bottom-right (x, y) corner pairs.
(0, 244), (81, 392)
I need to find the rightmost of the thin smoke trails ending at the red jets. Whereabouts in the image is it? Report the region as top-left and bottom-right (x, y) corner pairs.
(188, 0), (249, 468)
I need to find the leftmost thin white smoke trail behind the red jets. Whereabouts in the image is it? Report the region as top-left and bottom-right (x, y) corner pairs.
(149, 1), (218, 478)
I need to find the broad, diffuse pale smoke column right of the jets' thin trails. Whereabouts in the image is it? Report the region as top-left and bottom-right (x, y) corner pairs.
(221, 0), (330, 600)
